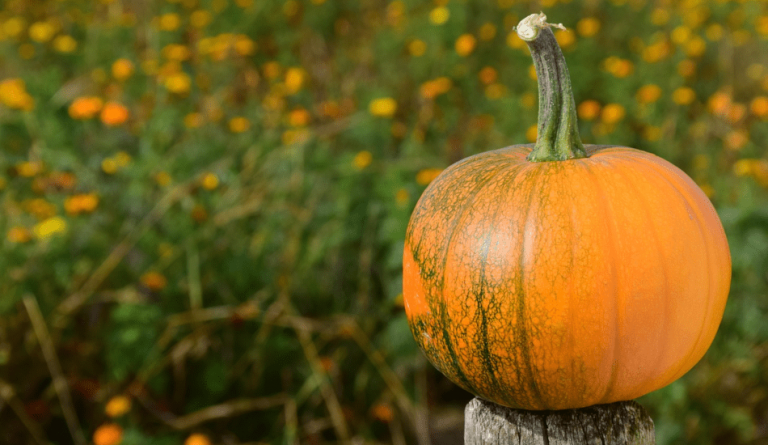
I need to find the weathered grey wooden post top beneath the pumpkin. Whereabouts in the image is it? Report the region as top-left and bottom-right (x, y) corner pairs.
(464, 397), (656, 445)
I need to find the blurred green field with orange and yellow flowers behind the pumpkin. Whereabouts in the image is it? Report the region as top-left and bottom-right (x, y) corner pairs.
(0, 0), (768, 445)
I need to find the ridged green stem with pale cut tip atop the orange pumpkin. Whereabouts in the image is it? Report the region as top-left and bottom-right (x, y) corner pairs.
(517, 13), (587, 162)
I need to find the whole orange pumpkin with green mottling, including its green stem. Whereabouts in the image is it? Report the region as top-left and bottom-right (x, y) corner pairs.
(403, 14), (731, 410)
